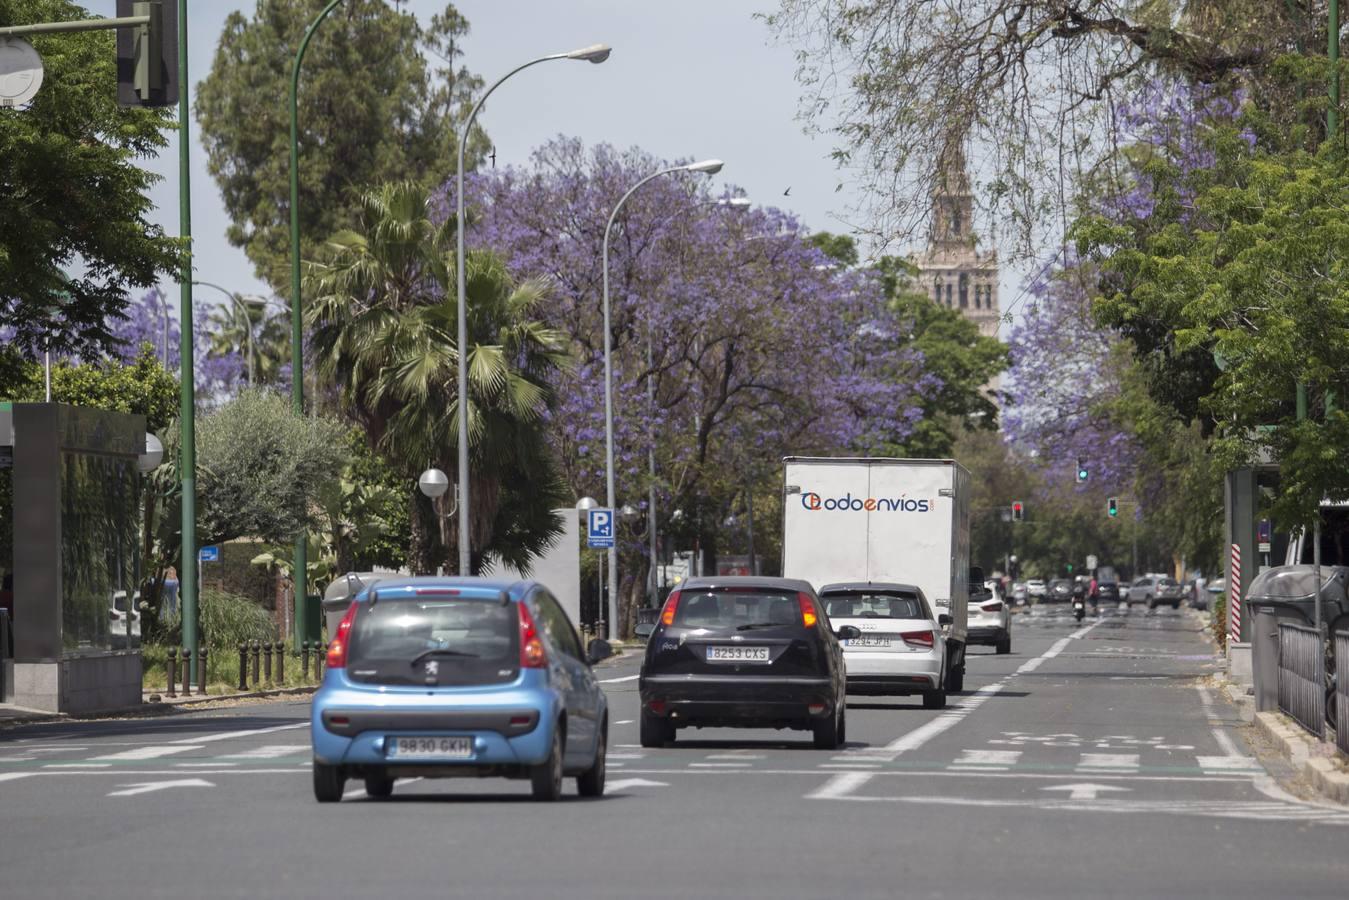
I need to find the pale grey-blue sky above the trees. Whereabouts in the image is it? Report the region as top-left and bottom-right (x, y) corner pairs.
(84, 0), (1018, 319)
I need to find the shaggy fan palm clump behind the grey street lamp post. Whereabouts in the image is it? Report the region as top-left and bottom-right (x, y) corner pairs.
(305, 184), (569, 571)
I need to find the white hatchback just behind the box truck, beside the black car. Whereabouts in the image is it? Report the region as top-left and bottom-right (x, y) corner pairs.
(819, 582), (949, 710)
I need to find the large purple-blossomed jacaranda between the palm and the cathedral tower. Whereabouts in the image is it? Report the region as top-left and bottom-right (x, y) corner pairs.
(438, 139), (923, 633)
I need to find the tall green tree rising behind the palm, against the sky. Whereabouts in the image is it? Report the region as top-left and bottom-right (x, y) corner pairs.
(196, 0), (490, 290)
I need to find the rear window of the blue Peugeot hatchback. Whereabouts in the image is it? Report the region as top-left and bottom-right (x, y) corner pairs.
(347, 598), (519, 684)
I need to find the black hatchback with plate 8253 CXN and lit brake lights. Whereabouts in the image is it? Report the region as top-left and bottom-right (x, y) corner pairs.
(638, 576), (861, 750)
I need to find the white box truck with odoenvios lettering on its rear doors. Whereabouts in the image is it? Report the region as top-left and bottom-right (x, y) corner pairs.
(782, 456), (970, 691)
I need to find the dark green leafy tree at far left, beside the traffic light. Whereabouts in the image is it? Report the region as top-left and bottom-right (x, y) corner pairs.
(0, 0), (177, 356)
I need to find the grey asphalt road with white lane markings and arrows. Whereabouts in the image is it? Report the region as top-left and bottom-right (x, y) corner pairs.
(0, 607), (1349, 900)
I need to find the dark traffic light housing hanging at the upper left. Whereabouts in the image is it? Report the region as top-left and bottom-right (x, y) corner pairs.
(117, 0), (178, 107)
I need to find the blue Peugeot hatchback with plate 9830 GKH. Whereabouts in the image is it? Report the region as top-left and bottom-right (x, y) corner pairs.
(310, 576), (612, 803)
